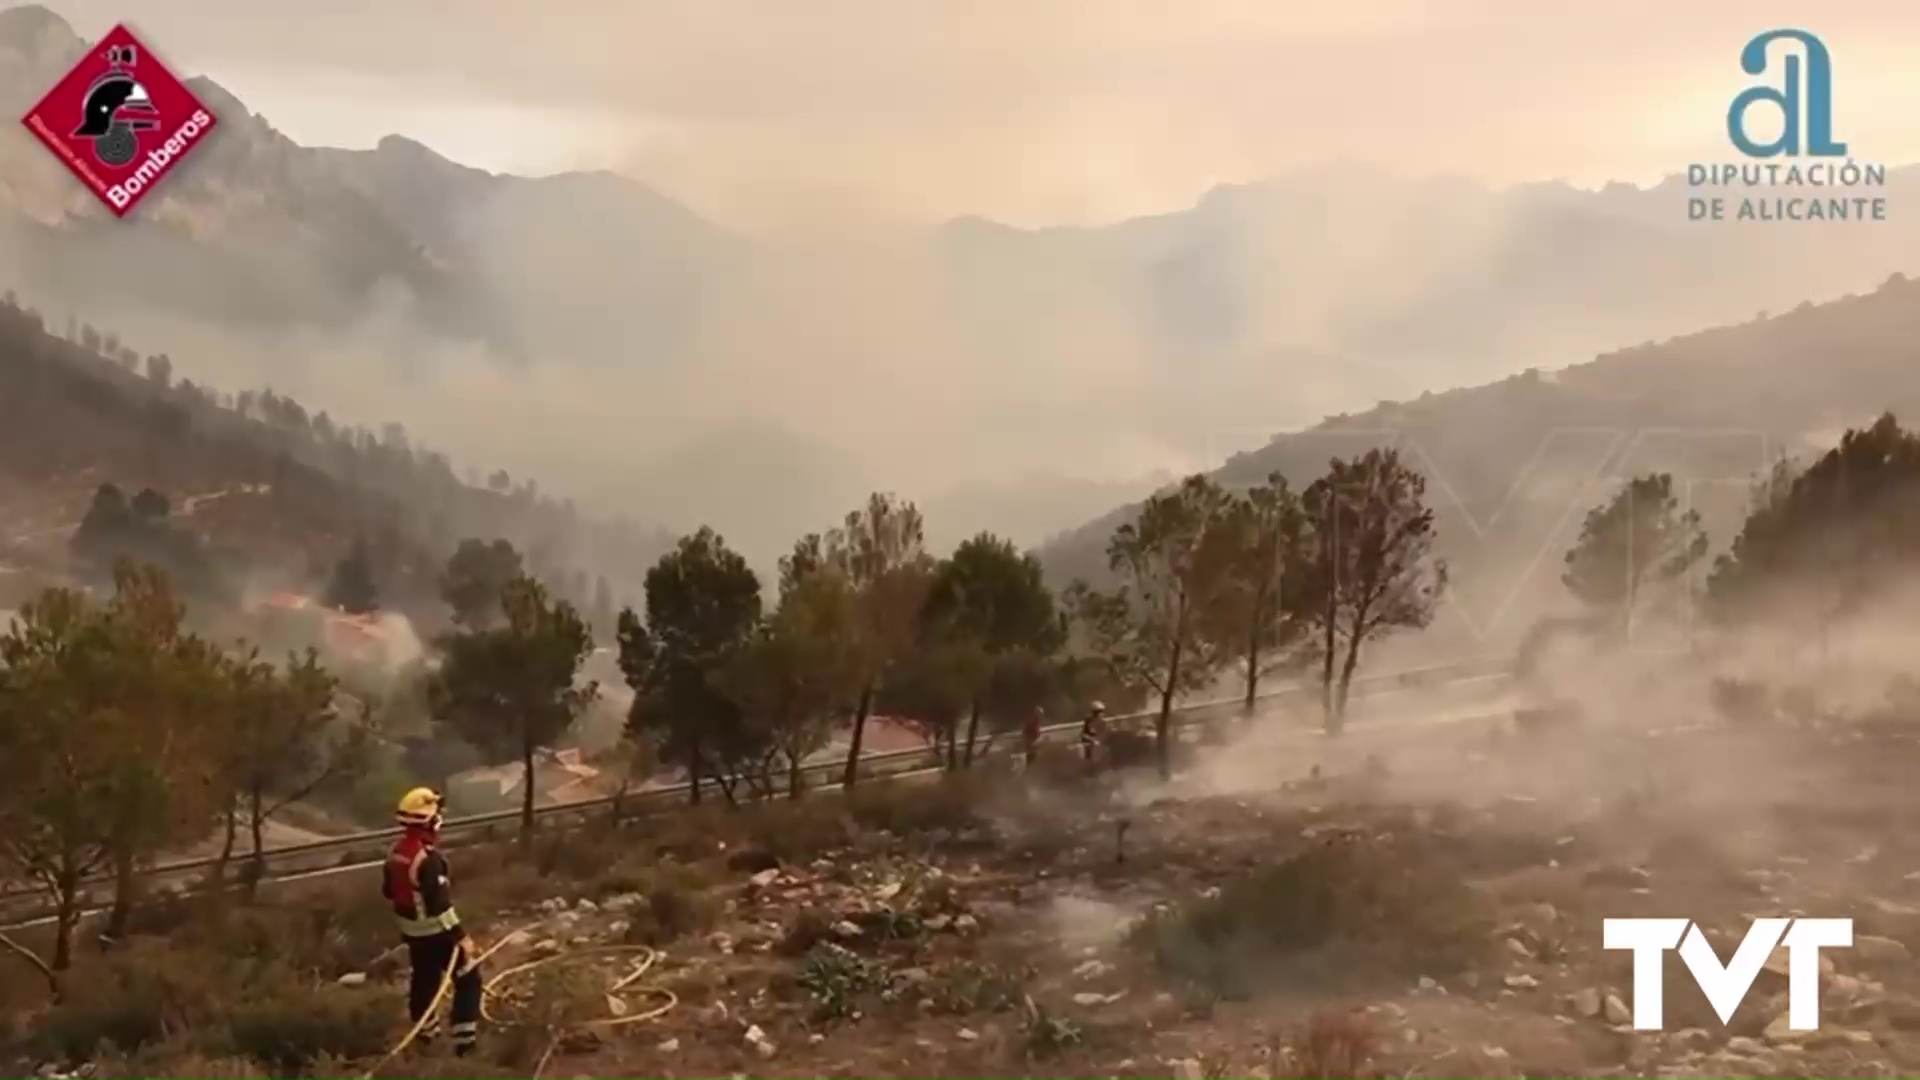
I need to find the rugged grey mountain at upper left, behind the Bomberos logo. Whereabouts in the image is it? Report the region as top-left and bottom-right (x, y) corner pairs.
(0, 8), (730, 361)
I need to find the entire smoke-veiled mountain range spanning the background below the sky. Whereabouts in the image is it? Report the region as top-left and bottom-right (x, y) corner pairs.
(0, 6), (1920, 564)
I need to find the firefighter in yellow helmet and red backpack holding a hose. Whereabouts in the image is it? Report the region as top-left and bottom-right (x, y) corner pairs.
(380, 788), (482, 1055)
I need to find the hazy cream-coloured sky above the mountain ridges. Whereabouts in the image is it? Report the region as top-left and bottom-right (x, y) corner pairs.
(30, 0), (1920, 223)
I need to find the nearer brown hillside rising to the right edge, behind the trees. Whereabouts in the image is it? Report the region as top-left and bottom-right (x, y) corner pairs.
(1041, 275), (1920, 648)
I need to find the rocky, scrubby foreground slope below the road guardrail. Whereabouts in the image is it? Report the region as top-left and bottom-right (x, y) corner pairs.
(11, 707), (1920, 1080)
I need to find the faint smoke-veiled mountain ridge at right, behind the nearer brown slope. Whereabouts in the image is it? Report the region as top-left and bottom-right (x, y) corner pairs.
(941, 165), (1920, 405)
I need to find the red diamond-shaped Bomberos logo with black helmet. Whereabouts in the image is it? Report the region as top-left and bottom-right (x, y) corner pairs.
(21, 25), (215, 217)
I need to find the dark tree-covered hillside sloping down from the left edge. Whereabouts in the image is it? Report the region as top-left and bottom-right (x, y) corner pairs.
(0, 296), (666, 619)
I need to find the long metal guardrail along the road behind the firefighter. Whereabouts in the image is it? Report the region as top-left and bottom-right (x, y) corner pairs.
(0, 657), (1513, 903)
